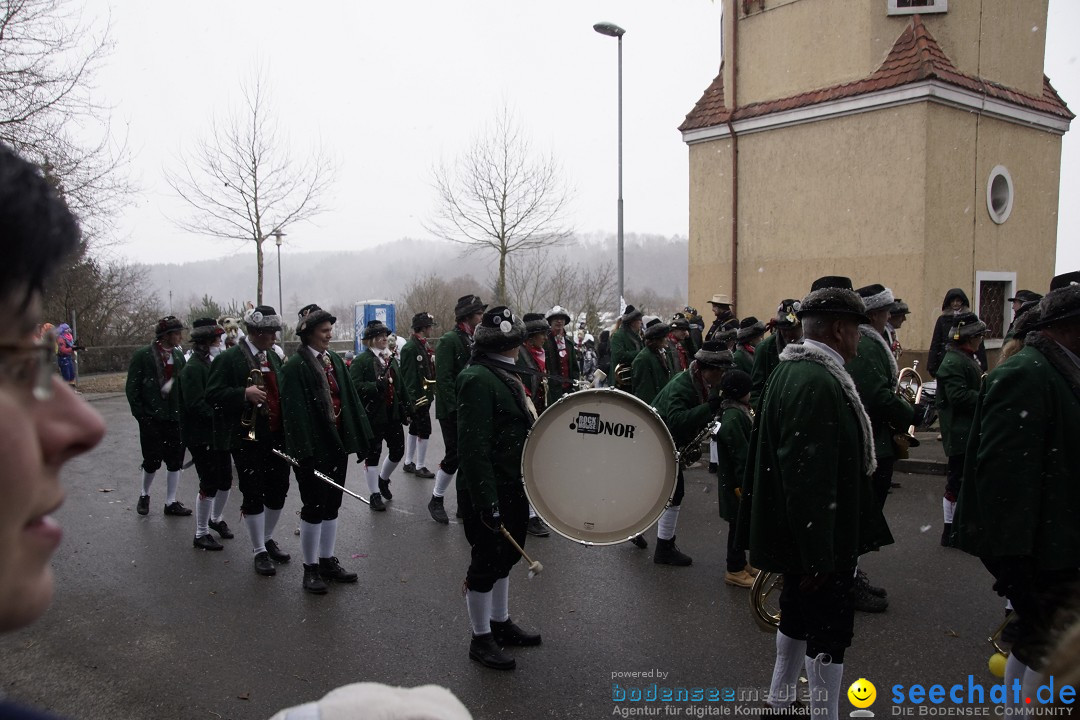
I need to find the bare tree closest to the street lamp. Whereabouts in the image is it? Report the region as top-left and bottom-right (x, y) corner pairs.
(427, 107), (572, 303)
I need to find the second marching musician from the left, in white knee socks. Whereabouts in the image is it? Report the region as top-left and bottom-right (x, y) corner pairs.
(179, 317), (233, 551)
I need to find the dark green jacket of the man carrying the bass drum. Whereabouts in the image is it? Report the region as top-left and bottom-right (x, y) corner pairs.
(457, 365), (532, 508)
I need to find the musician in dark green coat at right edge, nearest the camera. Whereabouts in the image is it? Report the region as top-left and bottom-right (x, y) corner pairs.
(953, 273), (1080, 711)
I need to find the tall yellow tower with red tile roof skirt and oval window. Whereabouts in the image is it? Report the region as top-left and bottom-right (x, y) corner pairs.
(679, 0), (1074, 359)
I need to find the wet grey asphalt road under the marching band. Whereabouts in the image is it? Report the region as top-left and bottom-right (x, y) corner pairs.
(0, 397), (1003, 720)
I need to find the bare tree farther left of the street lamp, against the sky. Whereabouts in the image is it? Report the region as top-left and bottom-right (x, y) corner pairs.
(166, 74), (334, 310)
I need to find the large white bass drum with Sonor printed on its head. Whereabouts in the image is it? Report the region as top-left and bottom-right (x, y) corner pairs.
(522, 389), (678, 545)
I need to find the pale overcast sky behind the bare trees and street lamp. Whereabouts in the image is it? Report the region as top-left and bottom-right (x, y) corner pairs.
(97, 0), (1080, 272)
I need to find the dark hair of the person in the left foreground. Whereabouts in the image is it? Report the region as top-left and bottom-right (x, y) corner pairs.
(0, 142), (80, 309)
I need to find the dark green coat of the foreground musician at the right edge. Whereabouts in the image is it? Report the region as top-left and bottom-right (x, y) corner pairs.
(953, 331), (1080, 570)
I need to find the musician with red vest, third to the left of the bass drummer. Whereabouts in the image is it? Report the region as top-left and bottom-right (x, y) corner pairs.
(400, 312), (435, 479)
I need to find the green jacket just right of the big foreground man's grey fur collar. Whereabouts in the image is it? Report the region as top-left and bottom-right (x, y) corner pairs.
(847, 326), (915, 460)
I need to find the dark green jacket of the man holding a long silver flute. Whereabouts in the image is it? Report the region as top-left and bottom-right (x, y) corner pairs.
(281, 348), (372, 461)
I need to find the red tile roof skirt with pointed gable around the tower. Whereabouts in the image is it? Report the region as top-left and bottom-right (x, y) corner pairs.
(679, 15), (1076, 132)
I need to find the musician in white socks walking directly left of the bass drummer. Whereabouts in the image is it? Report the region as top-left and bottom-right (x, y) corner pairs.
(428, 295), (487, 525)
